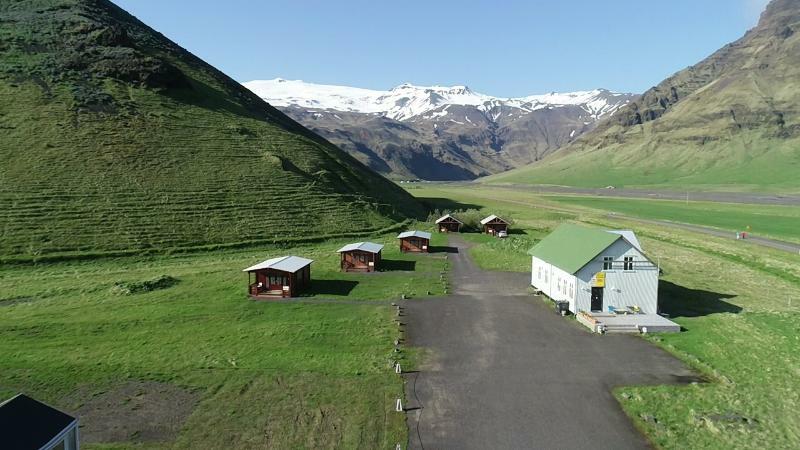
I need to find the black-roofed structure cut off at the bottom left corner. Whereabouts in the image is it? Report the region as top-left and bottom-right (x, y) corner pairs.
(0, 394), (78, 450)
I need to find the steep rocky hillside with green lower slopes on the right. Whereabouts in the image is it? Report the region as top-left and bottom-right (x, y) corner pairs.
(487, 0), (800, 191)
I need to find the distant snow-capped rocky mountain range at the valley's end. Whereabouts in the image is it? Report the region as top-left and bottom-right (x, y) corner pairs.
(244, 79), (635, 180)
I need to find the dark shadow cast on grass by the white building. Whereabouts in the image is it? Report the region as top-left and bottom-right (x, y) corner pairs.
(658, 280), (742, 317)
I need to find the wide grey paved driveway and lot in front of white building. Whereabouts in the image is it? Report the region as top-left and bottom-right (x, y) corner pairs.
(403, 237), (695, 449)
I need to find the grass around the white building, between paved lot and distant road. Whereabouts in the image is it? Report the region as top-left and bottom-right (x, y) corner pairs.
(410, 186), (800, 449)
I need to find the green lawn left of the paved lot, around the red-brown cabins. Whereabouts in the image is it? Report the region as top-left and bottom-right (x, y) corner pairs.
(0, 230), (446, 449)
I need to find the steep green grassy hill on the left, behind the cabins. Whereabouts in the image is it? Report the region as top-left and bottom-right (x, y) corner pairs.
(0, 0), (422, 260)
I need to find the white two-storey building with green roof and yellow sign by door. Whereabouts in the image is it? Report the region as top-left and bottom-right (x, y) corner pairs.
(529, 224), (659, 314)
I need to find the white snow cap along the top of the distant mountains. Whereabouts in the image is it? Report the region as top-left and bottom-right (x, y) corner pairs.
(243, 78), (630, 123)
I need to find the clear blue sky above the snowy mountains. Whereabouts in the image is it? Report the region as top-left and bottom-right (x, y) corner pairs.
(115, 0), (767, 97)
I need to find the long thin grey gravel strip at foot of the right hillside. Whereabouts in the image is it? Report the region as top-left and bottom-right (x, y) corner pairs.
(490, 184), (800, 206)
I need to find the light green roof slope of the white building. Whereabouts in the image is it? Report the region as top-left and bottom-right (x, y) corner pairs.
(528, 223), (622, 274)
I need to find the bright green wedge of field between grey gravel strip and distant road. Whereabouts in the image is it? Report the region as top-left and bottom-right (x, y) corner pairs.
(546, 196), (800, 242)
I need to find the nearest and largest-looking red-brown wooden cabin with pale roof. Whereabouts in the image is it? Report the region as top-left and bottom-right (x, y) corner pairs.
(243, 256), (314, 298)
